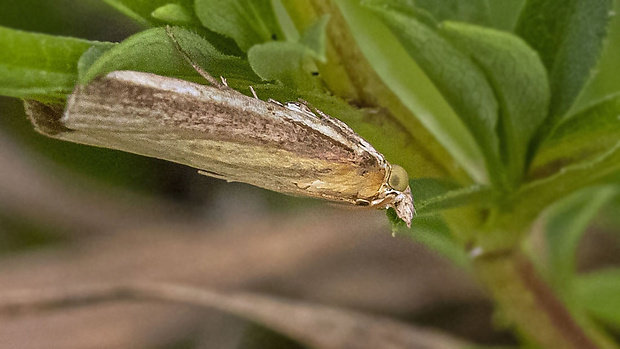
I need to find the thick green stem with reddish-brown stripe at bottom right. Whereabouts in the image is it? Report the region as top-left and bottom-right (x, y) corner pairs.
(473, 251), (614, 349)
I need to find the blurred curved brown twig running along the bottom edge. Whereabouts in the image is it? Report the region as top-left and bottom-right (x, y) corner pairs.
(0, 283), (465, 349)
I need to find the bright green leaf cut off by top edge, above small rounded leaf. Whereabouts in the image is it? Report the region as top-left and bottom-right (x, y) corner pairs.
(103, 0), (193, 27)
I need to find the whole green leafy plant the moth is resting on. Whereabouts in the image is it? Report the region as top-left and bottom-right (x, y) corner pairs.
(0, 0), (620, 348)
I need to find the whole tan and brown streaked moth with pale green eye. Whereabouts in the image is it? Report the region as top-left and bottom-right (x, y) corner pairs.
(26, 34), (415, 226)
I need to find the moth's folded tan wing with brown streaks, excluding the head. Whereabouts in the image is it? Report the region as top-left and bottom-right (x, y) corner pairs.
(30, 72), (385, 203)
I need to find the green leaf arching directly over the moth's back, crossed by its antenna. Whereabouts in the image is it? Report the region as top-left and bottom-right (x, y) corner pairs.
(80, 28), (259, 83)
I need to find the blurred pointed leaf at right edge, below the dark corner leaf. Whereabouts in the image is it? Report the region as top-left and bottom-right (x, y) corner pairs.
(532, 94), (620, 176)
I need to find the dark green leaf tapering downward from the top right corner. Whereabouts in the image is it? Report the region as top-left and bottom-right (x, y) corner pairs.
(517, 0), (613, 123)
